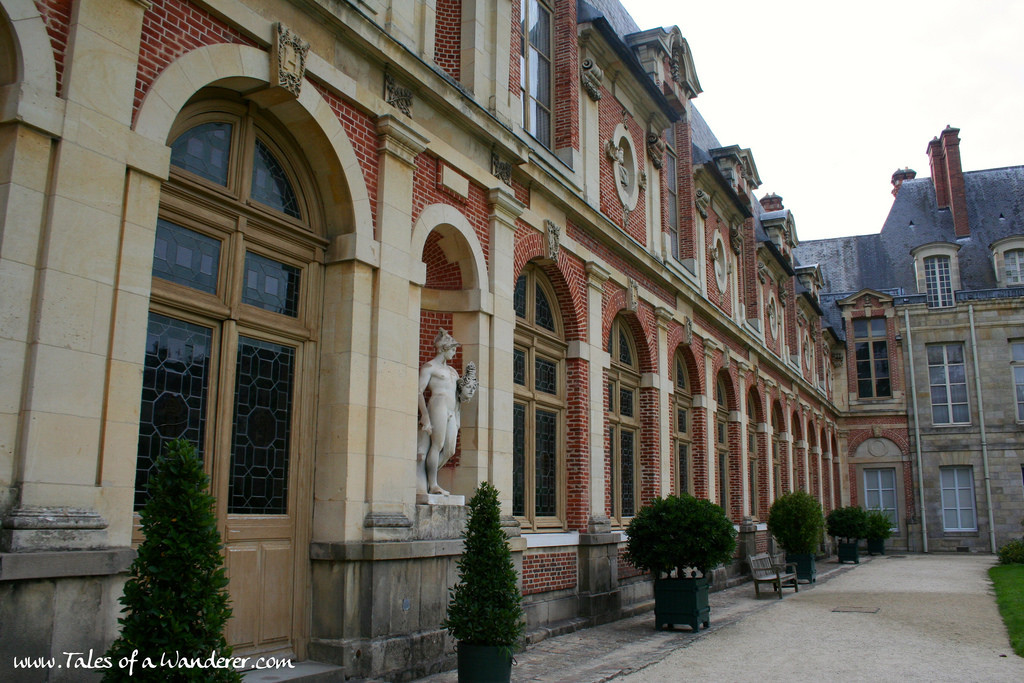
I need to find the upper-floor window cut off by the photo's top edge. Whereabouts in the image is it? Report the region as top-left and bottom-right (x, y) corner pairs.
(519, 0), (554, 147)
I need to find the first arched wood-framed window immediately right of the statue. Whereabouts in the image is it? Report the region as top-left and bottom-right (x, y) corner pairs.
(512, 265), (566, 529)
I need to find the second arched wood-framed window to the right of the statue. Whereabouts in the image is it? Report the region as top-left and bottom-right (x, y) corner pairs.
(607, 317), (640, 523)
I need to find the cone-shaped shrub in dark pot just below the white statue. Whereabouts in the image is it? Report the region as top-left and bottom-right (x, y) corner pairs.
(441, 481), (525, 683)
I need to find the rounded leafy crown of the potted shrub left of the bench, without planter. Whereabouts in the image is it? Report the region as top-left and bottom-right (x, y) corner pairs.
(626, 494), (736, 578)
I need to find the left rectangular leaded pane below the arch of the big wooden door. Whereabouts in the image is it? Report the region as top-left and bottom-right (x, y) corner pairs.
(153, 218), (220, 294)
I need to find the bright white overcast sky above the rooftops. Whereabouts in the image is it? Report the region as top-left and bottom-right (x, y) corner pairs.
(621, 0), (1024, 240)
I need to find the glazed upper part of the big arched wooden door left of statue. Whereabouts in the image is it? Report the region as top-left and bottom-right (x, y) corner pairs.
(135, 102), (323, 515)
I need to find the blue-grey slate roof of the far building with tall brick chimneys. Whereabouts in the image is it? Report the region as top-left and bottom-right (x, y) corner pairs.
(797, 166), (1024, 294)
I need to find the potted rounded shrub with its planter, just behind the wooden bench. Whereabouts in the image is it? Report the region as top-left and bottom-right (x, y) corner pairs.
(768, 490), (824, 584)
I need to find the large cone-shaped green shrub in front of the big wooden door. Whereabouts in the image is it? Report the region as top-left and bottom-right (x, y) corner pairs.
(103, 439), (242, 681)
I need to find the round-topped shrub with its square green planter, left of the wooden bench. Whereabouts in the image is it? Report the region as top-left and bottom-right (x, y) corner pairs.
(626, 494), (736, 631)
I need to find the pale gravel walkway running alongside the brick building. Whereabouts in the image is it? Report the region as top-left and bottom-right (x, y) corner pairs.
(411, 555), (1024, 683)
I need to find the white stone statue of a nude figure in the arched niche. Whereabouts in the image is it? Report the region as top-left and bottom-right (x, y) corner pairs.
(416, 330), (479, 496)
